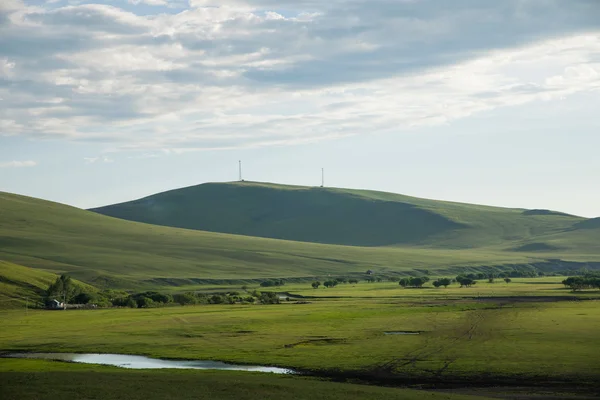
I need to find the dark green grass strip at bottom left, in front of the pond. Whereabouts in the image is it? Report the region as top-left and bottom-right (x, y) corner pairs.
(0, 360), (492, 400)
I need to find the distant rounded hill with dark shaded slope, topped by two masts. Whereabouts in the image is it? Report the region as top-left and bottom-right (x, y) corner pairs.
(91, 182), (584, 248)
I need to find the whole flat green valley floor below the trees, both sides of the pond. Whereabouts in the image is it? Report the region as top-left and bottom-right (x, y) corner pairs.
(0, 278), (600, 399)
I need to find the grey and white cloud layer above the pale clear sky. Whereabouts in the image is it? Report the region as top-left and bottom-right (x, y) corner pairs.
(0, 0), (600, 153)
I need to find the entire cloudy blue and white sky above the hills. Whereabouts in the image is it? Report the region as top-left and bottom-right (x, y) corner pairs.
(0, 0), (600, 217)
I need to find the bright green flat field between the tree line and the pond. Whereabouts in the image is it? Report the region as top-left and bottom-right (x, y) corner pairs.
(0, 278), (600, 394)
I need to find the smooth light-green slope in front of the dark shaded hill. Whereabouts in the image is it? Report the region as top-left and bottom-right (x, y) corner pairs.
(0, 193), (600, 290)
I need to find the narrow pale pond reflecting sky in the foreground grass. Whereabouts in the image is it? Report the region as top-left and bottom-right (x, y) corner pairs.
(3, 353), (296, 374)
